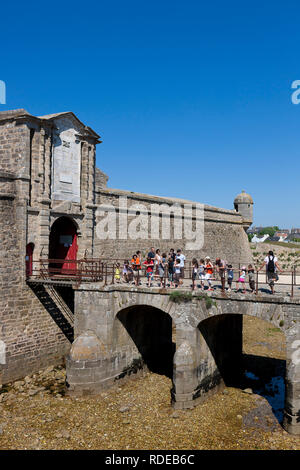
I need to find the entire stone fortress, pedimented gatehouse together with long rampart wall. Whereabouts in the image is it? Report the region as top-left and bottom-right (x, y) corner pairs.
(0, 109), (252, 384)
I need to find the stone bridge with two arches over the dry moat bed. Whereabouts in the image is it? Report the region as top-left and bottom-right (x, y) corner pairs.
(67, 283), (300, 434)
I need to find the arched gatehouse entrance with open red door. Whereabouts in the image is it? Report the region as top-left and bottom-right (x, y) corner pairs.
(49, 216), (78, 273)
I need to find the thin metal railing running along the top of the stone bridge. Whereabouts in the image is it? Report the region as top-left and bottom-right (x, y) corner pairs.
(28, 258), (300, 297)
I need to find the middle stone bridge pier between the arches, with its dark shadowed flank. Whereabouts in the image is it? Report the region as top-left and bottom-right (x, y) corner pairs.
(172, 314), (243, 408)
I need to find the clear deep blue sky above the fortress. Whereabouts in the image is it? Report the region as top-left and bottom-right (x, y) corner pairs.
(0, 0), (300, 228)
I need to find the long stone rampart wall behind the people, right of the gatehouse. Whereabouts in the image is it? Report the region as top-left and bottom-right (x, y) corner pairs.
(95, 188), (252, 266)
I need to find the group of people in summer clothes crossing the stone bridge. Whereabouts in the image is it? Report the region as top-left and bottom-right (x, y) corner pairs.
(115, 247), (281, 294)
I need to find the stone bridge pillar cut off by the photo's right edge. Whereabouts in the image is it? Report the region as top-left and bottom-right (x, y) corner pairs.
(283, 325), (300, 435)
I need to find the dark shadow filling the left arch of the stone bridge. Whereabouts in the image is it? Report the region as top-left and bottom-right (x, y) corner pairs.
(117, 306), (176, 379)
